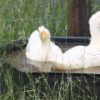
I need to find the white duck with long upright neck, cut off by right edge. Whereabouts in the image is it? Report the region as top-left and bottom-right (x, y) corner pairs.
(63, 11), (100, 69)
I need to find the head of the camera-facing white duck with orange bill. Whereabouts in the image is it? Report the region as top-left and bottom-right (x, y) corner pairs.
(38, 26), (50, 42)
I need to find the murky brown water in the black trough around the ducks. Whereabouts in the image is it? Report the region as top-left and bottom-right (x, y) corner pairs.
(0, 38), (100, 74)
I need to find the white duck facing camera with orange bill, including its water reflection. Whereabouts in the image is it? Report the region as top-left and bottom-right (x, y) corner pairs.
(26, 26), (62, 72)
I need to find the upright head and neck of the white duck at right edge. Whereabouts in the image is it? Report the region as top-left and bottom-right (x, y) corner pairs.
(89, 11), (100, 49)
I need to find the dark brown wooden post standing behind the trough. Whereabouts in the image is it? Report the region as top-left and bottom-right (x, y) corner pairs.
(68, 0), (91, 36)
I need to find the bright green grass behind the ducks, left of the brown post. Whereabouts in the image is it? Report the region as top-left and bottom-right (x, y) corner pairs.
(0, 0), (67, 40)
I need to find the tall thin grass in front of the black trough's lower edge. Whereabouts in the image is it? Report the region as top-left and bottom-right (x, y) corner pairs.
(0, 65), (99, 100)
